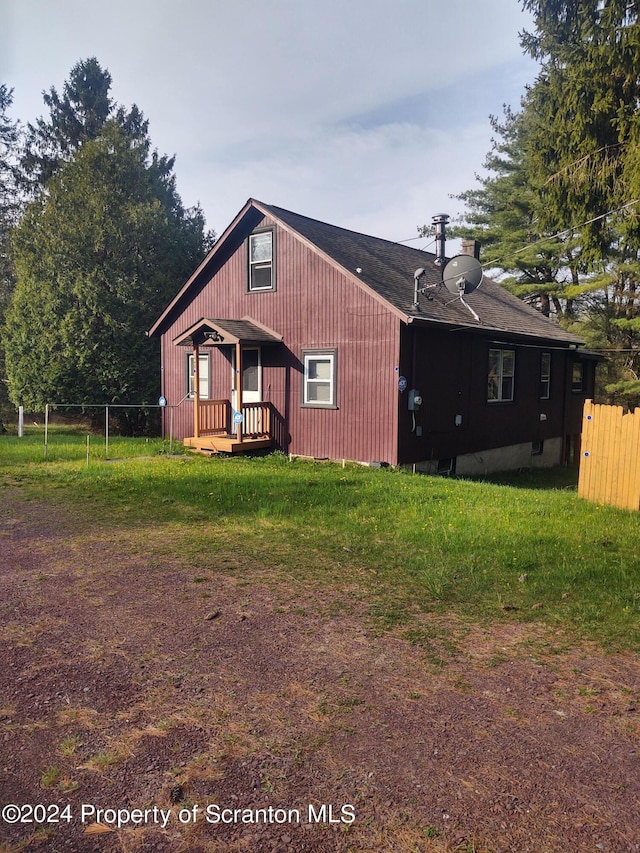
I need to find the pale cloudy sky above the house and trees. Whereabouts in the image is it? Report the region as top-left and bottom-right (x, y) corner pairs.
(0, 0), (536, 246)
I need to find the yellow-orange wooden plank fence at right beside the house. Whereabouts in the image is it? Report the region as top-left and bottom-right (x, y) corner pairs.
(578, 400), (640, 509)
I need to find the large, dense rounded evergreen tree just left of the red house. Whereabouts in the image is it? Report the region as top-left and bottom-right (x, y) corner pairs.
(5, 120), (206, 432)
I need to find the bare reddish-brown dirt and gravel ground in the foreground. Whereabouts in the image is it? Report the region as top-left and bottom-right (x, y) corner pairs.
(0, 490), (640, 853)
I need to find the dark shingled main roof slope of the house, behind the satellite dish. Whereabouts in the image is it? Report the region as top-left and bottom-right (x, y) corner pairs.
(258, 202), (583, 345)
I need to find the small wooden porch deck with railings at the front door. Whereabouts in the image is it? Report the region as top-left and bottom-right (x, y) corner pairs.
(183, 398), (274, 454)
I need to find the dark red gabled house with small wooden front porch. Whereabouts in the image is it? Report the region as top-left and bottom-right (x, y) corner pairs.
(148, 199), (596, 474)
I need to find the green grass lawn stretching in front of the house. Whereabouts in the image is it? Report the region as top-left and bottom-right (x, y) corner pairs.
(0, 430), (640, 649)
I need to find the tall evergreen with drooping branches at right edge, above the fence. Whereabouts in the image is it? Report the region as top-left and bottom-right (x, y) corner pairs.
(522, 0), (640, 404)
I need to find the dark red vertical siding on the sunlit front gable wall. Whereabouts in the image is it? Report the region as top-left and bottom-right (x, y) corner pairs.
(162, 217), (400, 464)
